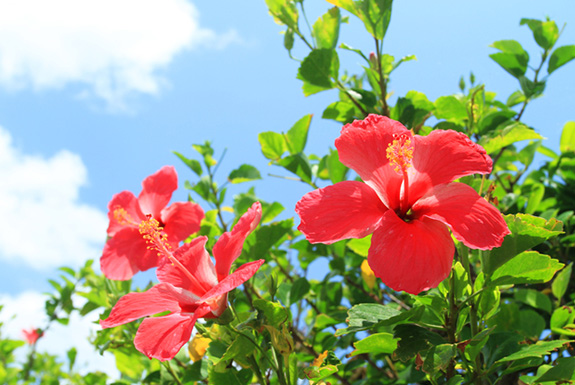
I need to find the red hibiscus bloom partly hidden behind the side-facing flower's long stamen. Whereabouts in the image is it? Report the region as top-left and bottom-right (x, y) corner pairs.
(100, 166), (204, 280)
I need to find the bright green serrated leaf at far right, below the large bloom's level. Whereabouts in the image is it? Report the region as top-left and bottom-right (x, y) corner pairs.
(490, 251), (564, 286)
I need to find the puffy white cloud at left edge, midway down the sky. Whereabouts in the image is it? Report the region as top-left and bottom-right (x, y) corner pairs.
(0, 127), (108, 270)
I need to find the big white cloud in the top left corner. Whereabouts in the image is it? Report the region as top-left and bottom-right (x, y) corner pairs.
(0, 0), (239, 108)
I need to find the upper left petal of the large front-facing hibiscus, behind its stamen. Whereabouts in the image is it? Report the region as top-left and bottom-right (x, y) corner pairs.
(335, 115), (412, 209)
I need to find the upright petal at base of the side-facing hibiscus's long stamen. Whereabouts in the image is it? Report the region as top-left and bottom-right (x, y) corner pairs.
(156, 236), (218, 297)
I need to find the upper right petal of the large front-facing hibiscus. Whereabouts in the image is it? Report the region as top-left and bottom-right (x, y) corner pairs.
(408, 130), (492, 203)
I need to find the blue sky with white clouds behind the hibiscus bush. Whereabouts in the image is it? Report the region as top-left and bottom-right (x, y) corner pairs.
(0, 0), (575, 376)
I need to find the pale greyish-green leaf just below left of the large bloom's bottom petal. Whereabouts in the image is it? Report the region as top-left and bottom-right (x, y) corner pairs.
(335, 303), (413, 336)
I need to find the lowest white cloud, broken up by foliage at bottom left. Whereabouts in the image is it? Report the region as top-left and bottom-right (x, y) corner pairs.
(0, 291), (119, 378)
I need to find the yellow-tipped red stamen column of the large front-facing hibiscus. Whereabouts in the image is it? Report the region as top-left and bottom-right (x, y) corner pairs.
(386, 134), (413, 218)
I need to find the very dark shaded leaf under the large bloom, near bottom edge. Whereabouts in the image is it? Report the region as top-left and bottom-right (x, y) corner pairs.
(393, 324), (445, 362)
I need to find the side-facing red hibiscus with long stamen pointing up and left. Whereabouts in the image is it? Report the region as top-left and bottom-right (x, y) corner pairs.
(100, 202), (264, 361)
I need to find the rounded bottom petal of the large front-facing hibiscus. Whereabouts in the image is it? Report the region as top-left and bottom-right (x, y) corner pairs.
(367, 210), (455, 294)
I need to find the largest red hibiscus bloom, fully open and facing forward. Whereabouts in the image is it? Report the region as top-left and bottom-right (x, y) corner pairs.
(296, 115), (509, 294)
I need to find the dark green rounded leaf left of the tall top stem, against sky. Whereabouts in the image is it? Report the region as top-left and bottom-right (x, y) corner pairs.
(297, 48), (339, 92)
